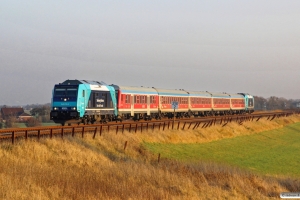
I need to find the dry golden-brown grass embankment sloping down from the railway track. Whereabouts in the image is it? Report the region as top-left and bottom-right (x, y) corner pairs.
(0, 116), (300, 199)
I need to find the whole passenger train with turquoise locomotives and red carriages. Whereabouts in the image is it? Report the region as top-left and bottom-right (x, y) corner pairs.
(50, 79), (254, 125)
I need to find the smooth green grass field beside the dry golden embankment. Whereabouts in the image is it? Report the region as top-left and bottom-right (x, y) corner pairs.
(144, 123), (300, 177)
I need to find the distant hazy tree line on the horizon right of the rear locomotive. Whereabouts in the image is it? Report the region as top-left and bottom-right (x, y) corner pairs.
(254, 96), (300, 110)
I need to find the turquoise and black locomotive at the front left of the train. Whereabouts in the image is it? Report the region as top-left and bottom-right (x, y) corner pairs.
(50, 80), (118, 125)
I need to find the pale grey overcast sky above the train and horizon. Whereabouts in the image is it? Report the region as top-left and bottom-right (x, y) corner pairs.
(0, 0), (300, 105)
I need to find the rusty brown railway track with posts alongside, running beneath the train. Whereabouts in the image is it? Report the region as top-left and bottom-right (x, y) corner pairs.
(0, 111), (299, 144)
